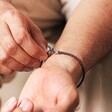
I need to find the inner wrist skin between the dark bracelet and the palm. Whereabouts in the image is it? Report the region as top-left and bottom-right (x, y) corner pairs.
(42, 54), (82, 84)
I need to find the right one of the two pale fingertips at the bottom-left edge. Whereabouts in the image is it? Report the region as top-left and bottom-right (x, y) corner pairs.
(19, 99), (33, 112)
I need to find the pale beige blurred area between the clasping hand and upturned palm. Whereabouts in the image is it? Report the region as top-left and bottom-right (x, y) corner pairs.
(0, 72), (31, 105)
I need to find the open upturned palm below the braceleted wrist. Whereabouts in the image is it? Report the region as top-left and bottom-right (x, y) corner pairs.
(19, 54), (79, 112)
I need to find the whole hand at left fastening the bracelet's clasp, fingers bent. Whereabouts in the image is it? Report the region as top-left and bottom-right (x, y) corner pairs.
(0, 1), (47, 74)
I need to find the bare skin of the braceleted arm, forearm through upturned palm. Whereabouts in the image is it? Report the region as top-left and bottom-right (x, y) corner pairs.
(1, 0), (112, 112)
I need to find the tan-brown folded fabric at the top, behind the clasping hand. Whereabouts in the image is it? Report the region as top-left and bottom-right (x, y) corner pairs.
(11, 0), (63, 29)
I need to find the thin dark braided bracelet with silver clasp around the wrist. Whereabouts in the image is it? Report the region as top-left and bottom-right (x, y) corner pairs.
(47, 46), (85, 88)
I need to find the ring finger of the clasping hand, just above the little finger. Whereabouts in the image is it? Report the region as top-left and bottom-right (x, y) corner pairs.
(0, 46), (32, 71)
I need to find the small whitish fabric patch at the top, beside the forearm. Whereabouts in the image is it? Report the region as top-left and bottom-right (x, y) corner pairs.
(60, 0), (81, 19)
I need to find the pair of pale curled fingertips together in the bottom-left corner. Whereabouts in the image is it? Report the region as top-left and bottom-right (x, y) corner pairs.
(1, 97), (33, 112)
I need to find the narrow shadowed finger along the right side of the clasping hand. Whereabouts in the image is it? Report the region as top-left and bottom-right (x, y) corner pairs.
(29, 19), (47, 51)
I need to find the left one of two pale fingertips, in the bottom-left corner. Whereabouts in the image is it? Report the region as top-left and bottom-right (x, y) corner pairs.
(1, 97), (17, 112)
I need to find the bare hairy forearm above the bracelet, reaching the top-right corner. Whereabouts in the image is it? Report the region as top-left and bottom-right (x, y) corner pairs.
(55, 0), (112, 71)
